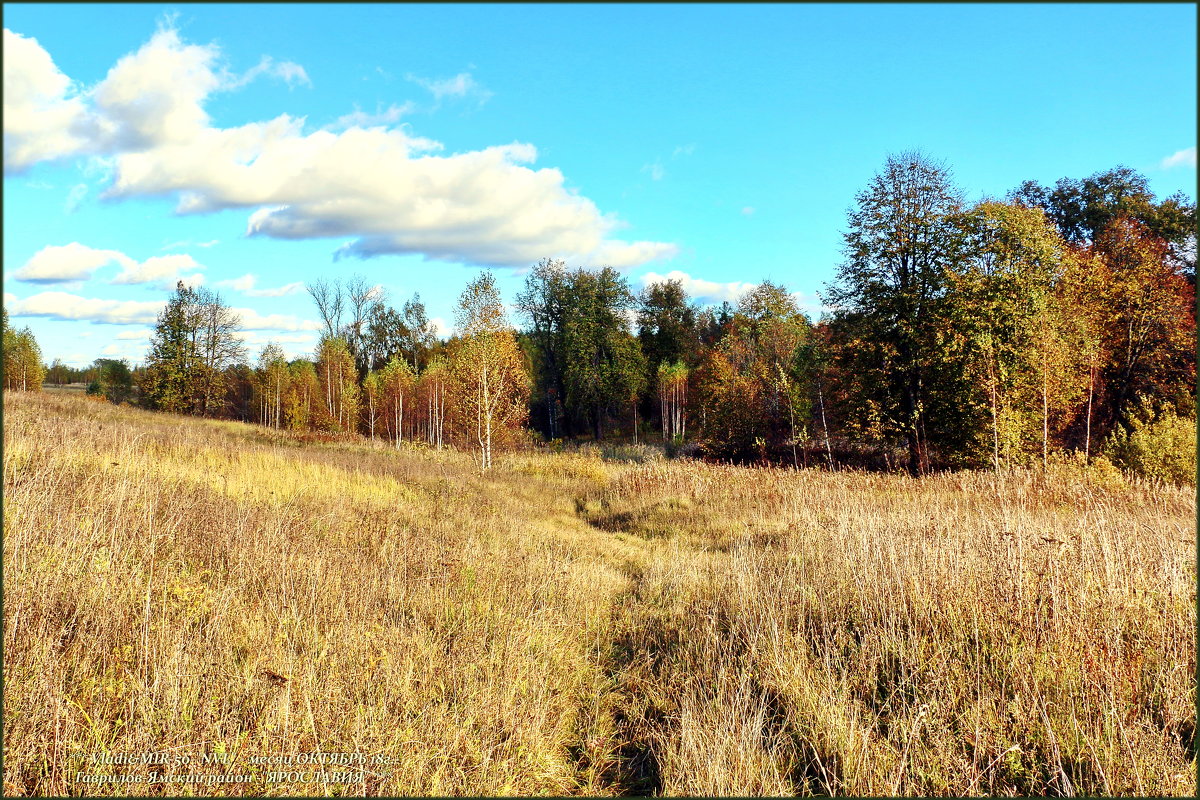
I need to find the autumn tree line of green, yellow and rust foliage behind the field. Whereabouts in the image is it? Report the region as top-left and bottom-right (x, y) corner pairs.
(5, 152), (1195, 474)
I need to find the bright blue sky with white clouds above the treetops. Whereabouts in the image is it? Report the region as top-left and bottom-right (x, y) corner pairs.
(2, 4), (1196, 366)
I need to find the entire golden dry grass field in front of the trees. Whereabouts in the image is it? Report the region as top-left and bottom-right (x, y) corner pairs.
(4, 393), (1196, 795)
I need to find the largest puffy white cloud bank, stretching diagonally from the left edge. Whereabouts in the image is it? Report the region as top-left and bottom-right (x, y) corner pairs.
(5, 29), (678, 269)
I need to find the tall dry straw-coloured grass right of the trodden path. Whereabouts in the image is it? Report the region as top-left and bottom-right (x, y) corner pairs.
(576, 464), (1195, 795)
